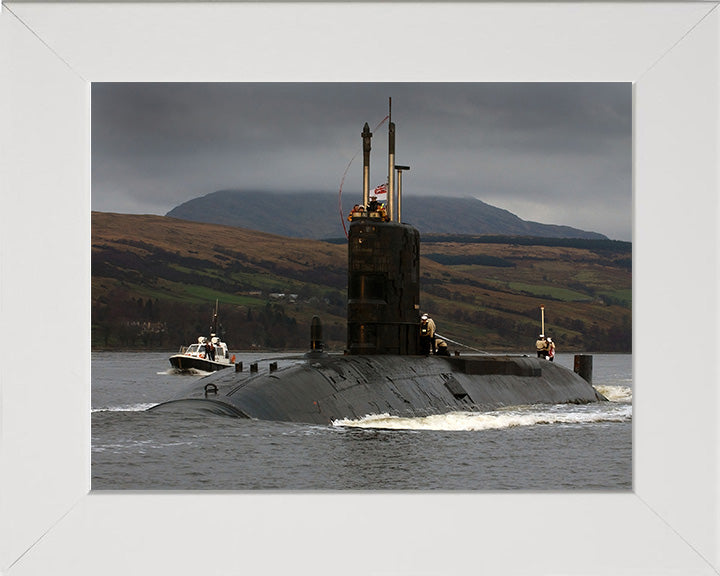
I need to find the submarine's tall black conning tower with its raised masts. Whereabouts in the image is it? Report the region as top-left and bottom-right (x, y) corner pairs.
(347, 113), (420, 355)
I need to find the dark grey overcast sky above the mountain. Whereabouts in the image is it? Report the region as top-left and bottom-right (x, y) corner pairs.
(92, 83), (632, 240)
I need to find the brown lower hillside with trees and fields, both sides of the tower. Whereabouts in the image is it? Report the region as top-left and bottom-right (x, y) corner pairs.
(92, 212), (632, 353)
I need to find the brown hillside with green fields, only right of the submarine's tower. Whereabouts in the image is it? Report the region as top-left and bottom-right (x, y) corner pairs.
(421, 237), (632, 352)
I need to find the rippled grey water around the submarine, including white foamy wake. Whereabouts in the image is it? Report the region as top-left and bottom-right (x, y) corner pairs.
(92, 353), (632, 490)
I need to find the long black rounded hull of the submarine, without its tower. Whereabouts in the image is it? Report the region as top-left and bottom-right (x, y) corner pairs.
(152, 355), (605, 424)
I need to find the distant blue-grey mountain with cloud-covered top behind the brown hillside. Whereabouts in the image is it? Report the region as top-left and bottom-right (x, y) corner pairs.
(166, 190), (605, 239)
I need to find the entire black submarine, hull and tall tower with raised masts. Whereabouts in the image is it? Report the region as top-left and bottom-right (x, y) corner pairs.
(150, 112), (606, 424)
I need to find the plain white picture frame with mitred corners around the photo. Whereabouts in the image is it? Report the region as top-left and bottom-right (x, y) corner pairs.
(0, 2), (720, 576)
